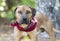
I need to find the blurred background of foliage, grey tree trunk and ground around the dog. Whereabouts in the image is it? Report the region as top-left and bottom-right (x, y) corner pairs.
(0, 0), (60, 41)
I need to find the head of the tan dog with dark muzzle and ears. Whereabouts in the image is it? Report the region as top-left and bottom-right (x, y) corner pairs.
(14, 5), (36, 24)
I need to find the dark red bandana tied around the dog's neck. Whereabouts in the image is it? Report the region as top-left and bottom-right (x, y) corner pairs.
(11, 18), (37, 32)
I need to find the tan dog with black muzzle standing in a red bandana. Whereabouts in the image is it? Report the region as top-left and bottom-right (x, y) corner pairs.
(14, 5), (59, 41)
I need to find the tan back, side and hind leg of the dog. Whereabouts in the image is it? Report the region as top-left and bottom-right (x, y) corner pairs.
(35, 14), (54, 41)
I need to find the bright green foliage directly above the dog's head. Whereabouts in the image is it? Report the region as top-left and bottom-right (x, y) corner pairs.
(18, 0), (36, 8)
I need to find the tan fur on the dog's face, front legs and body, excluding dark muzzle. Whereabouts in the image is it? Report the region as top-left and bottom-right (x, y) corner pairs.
(14, 5), (60, 41)
